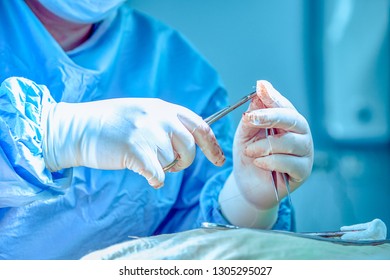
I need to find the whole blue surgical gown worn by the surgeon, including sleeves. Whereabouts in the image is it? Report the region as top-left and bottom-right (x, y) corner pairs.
(0, 0), (291, 259)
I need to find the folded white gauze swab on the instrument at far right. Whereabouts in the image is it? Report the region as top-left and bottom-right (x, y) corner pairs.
(340, 219), (387, 240)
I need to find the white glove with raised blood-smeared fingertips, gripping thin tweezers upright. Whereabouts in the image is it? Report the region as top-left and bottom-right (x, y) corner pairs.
(219, 81), (313, 228)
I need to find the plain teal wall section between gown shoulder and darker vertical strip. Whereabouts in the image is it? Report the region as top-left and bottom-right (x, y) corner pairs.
(130, 0), (308, 122)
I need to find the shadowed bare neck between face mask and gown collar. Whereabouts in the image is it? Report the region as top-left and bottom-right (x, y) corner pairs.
(25, 0), (92, 51)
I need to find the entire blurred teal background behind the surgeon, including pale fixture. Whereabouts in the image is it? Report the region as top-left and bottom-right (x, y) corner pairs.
(131, 0), (390, 236)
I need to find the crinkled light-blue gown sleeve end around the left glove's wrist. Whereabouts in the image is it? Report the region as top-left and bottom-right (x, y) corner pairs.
(0, 77), (71, 208)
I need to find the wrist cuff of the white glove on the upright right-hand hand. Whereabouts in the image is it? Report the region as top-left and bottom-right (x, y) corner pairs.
(218, 174), (279, 229)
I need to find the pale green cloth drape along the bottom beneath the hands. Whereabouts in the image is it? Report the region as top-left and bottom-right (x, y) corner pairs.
(83, 229), (390, 260)
